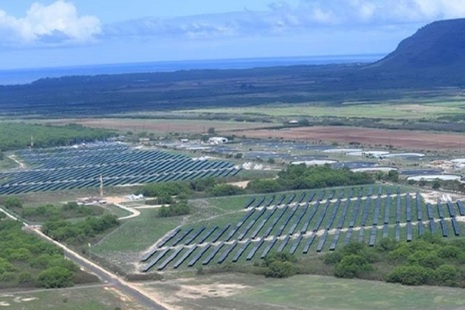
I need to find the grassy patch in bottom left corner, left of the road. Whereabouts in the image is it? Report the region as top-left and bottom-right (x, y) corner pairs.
(0, 286), (146, 310)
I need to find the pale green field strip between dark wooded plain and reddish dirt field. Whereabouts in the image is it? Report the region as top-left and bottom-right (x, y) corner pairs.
(183, 98), (465, 119)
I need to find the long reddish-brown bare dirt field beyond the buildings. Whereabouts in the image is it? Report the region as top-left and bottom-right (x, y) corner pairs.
(232, 126), (465, 151)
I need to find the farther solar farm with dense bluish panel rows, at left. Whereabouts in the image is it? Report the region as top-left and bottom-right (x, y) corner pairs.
(0, 144), (239, 195)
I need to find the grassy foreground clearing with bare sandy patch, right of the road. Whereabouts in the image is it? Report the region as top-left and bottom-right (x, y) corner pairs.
(143, 273), (465, 310)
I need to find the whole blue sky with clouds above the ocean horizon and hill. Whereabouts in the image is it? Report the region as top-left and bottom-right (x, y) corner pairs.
(0, 0), (465, 69)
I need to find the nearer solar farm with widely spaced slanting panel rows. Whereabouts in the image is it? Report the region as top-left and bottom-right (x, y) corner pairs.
(140, 186), (465, 272)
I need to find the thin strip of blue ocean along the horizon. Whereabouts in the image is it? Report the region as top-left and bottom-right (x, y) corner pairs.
(0, 54), (385, 85)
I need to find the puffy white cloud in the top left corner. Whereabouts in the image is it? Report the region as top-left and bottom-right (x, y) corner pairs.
(0, 0), (101, 45)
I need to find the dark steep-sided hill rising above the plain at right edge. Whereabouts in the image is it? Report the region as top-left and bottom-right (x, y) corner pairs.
(370, 18), (465, 71)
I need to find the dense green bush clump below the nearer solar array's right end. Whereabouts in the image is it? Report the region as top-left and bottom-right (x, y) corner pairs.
(325, 234), (465, 287)
